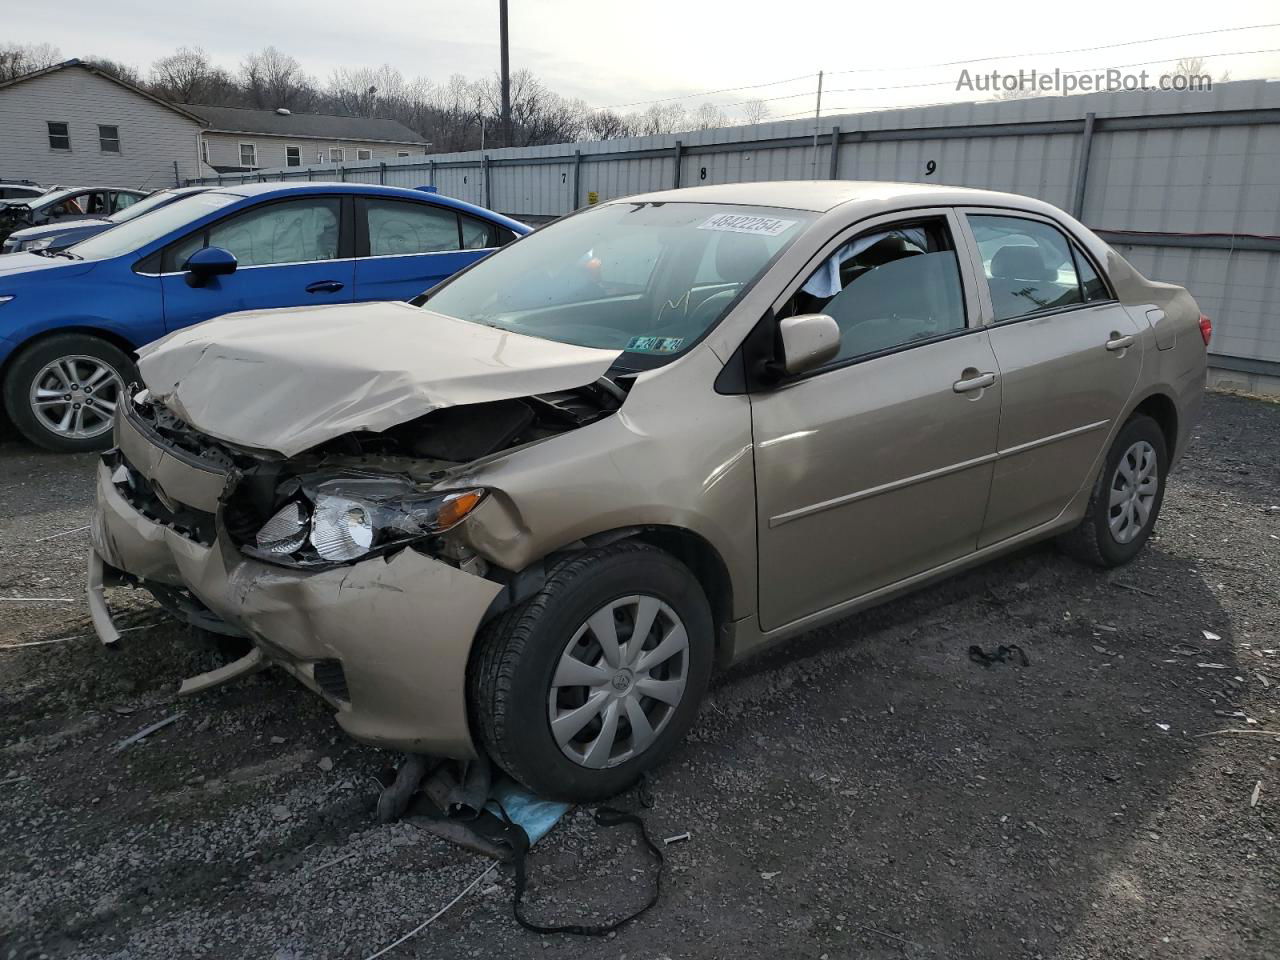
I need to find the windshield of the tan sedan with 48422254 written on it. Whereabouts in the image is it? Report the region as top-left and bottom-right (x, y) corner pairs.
(416, 202), (815, 356)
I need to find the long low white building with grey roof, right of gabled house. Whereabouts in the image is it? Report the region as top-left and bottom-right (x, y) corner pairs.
(189, 105), (430, 173)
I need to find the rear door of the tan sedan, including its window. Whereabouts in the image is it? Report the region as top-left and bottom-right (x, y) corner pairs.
(963, 209), (1142, 547)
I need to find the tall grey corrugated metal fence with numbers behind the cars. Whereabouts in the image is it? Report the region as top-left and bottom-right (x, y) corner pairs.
(191, 81), (1280, 378)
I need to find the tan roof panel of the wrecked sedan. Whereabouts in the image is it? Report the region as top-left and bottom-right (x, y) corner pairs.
(619, 180), (1044, 212)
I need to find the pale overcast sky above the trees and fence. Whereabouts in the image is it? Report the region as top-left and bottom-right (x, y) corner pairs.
(10, 0), (1280, 118)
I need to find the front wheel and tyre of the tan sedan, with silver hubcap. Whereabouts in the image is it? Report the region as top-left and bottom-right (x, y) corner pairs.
(470, 543), (714, 803)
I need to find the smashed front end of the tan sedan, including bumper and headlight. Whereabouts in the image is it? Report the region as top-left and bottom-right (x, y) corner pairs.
(90, 378), (627, 756)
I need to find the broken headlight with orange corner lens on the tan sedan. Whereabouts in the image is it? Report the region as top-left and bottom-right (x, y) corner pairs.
(252, 477), (485, 563)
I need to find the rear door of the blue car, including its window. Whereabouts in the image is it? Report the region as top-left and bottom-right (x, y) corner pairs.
(355, 197), (499, 300)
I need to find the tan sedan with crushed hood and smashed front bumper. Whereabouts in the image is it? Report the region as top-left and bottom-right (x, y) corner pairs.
(90, 182), (1210, 799)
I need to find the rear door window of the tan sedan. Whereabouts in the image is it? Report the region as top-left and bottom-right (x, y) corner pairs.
(969, 214), (1100, 323)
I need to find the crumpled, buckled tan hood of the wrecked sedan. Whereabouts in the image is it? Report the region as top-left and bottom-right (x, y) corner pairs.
(138, 302), (621, 457)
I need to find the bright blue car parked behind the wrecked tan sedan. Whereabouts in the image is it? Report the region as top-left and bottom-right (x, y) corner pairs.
(0, 183), (530, 451)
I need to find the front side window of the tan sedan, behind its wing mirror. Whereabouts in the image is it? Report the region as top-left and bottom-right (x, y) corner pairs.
(780, 220), (965, 364)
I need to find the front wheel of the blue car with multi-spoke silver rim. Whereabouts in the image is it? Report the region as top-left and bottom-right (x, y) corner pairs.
(4, 333), (134, 453)
